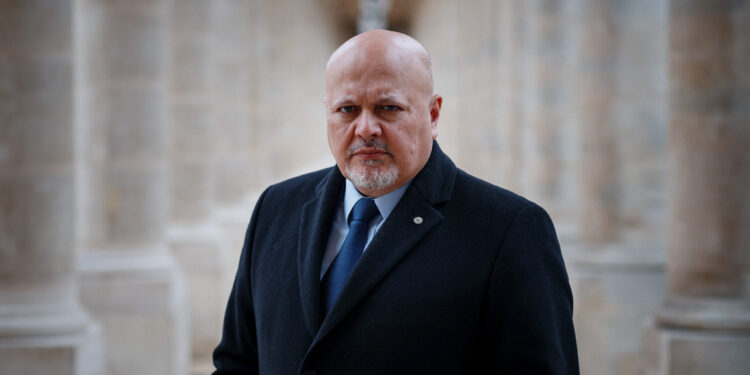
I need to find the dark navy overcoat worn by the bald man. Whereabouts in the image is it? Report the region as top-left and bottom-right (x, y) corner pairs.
(214, 143), (578, 375)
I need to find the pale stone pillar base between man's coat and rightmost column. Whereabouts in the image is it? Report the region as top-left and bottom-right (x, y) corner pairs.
(570, 245), (664, 375)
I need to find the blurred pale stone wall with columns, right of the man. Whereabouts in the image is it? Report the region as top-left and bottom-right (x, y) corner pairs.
(412, 0), (750, 374)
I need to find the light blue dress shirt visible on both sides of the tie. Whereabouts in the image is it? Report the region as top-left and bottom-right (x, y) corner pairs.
(320, 180), (411, 280)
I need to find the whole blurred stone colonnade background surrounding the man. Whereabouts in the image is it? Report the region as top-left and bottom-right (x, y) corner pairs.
(0, 0), (750, 375)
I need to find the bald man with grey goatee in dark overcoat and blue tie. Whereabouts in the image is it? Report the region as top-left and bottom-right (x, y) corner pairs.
(214, 30), (578, 375)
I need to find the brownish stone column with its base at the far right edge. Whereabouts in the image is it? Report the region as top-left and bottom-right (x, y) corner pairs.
(644, 0), (750, 375)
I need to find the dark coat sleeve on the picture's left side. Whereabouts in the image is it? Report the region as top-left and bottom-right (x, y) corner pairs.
(213, 192), (266, 375)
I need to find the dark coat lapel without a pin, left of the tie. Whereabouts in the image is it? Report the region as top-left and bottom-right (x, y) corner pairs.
(297, 167), (344, 338)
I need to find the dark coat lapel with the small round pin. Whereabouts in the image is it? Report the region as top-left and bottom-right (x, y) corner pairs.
(310, 143), (456, 347)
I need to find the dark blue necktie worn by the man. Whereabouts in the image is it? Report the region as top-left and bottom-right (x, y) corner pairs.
(321, 198), (379, 314)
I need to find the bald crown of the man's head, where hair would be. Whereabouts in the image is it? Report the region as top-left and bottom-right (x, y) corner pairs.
(326, 30), (433, 97)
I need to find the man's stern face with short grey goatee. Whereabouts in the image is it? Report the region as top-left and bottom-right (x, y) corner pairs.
(326, 46), (442, 197)
